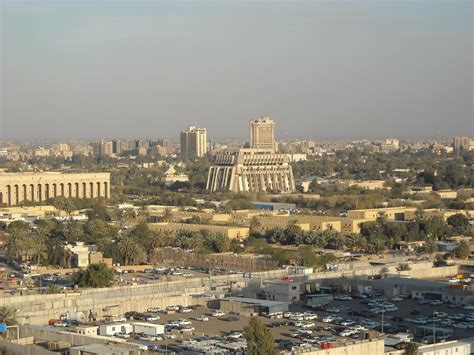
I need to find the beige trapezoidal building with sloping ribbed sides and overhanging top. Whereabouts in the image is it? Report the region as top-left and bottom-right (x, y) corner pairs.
(207, 149), (295, 192)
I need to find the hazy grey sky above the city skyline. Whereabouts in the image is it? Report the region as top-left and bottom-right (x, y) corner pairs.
(0, 0), (474, 138)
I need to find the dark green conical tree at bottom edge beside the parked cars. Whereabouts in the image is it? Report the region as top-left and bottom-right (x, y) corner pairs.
(244, 317), (278, 355)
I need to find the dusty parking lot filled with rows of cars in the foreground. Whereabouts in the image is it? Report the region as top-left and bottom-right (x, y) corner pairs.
(111, 298), (474, 350)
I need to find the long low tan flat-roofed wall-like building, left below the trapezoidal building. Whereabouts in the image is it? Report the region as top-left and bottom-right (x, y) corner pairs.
(148, 222), (249, 240)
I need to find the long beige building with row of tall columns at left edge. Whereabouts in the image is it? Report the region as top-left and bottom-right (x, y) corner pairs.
(0, 172), (110, 206)
